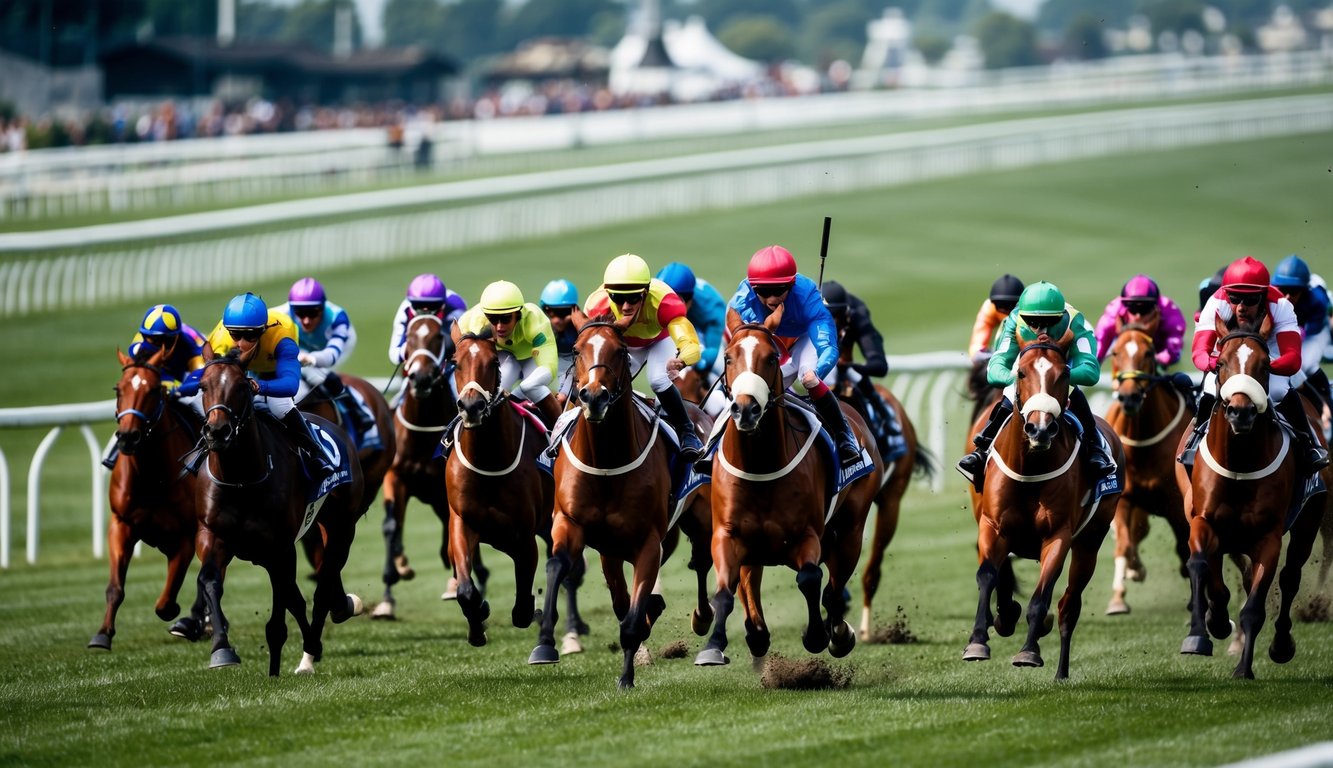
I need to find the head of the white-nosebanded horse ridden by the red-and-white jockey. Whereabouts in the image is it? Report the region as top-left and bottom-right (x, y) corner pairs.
(1216, 312), (1273, 435)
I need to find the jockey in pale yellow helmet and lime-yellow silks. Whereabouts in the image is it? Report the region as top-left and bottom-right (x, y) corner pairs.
(459, 280), (560, 429)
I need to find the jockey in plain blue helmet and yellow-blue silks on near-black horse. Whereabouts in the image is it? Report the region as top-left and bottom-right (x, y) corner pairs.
(180, 293), (336, 488)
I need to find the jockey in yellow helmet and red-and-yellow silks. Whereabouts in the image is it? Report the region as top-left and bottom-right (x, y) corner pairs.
(584, 253), (704, 461)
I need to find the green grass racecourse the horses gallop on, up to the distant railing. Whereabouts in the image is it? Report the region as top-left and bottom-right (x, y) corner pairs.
(0, 129), (1333, 767)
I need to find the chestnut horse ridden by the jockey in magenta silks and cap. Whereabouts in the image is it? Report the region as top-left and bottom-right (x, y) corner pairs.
(1106, 324), (1193, 615)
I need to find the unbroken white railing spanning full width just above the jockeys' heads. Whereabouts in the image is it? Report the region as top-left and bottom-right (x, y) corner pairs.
(0, 95), (1333, 316)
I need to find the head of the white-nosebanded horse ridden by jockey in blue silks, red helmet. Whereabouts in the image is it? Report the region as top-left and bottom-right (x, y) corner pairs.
(722, 304), (785, 432)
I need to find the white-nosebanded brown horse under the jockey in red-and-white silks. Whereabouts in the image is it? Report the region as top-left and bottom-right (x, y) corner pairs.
(1178, 313), (1333, 679)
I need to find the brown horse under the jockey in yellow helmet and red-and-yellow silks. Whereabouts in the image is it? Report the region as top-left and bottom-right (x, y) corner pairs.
(528, 315), (672, 688)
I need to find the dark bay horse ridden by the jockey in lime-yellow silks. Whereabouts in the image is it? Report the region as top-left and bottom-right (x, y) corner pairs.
(445, 330), (554, 645)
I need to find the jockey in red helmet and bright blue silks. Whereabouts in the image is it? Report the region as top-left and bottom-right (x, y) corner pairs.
(730, 245), (861, 469)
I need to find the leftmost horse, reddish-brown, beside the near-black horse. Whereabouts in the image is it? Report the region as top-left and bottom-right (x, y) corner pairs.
(88, 349), (204, 651)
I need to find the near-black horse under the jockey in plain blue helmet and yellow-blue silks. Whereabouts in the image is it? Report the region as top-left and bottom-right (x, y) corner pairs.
(196, 344), (365, 676)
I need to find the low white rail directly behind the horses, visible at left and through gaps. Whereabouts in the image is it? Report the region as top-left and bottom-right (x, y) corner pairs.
(0, 352), (1135, 568)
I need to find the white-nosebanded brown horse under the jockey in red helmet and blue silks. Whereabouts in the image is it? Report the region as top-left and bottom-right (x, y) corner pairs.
(694, 309), (882, 667)
